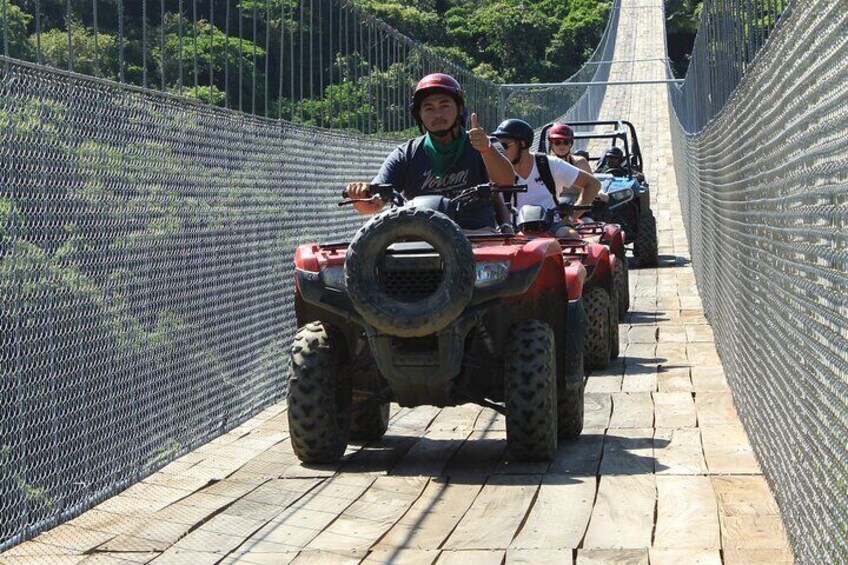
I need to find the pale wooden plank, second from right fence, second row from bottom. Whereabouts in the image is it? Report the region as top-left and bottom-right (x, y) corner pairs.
(653, 476), (721, 550)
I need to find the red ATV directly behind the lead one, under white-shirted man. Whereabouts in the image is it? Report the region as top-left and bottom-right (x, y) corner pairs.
(516, 197), (626, 369)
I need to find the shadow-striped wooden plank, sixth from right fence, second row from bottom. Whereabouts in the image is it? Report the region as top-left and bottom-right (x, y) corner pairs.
(376, 480), (482, 550)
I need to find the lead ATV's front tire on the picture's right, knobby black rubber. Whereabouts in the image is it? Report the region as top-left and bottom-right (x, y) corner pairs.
(504, 320), (557, 461)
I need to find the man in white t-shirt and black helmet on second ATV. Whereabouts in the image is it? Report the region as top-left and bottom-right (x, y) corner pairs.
(492, 118), (601, 237)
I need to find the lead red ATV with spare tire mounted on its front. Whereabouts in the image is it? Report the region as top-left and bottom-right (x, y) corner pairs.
(288, 184), (586, 463)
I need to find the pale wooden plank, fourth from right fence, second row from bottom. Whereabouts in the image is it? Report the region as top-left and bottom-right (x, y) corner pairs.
(510, 475), (597, 556)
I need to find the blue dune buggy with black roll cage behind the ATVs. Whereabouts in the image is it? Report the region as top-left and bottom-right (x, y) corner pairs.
(538, 120), (658, 267)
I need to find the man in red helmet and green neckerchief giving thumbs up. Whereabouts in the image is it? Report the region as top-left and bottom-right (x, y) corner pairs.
(347, 73), (515, 233)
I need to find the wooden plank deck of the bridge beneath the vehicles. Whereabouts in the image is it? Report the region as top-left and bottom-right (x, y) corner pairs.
(0, 0), (793, 565)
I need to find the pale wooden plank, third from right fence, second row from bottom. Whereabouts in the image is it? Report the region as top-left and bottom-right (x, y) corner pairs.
(578, 475), (657, 548)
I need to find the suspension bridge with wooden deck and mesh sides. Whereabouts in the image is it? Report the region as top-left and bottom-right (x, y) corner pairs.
(0, 0), (848, 565)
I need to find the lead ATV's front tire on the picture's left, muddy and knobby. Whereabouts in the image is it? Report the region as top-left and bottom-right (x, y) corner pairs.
(288, 322), (351, 463)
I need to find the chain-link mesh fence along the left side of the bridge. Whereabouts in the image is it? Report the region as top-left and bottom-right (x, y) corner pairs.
(0, 63), (400, 548)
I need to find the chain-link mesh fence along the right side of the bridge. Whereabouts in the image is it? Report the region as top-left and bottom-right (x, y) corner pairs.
(670, 0), (848, 564)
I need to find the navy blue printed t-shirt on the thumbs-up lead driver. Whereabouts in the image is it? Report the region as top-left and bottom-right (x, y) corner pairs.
(371, 135), (500, 229)
